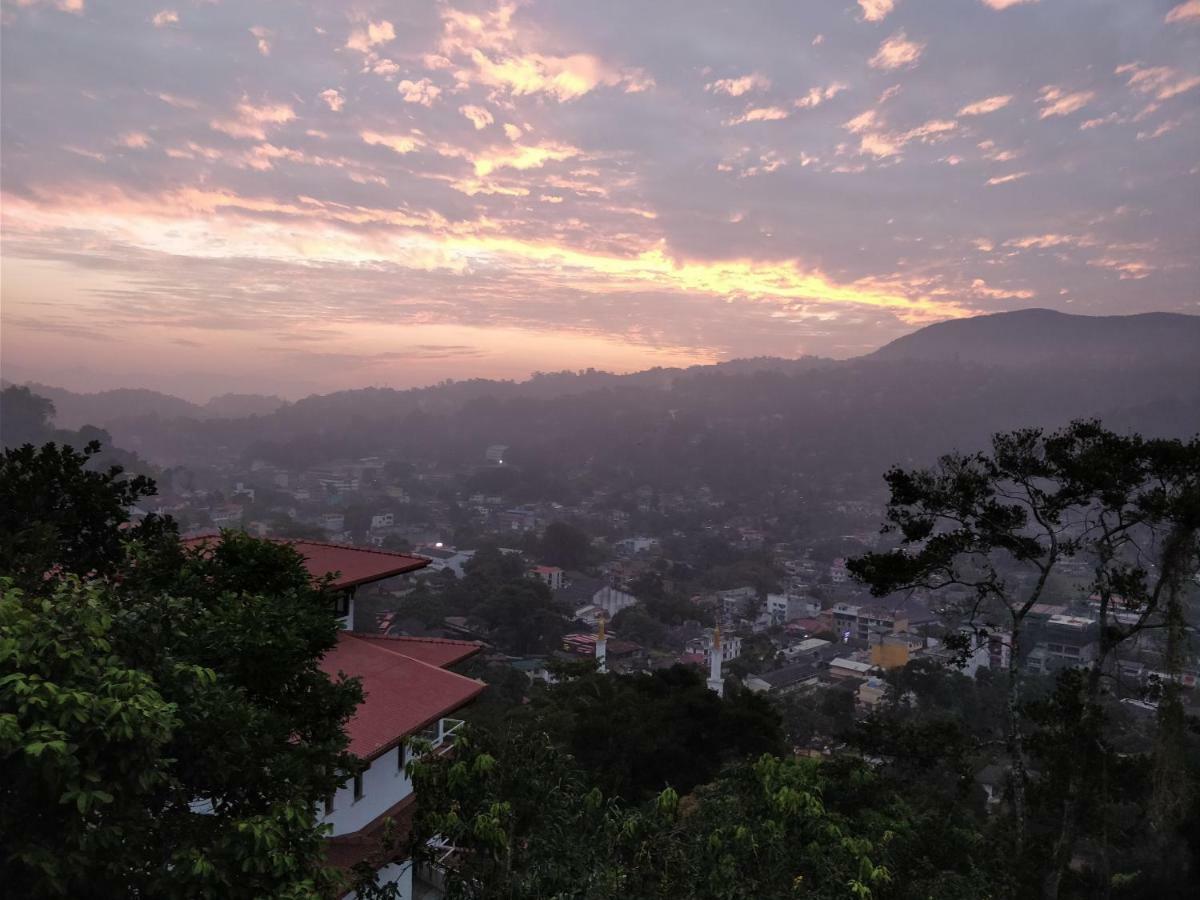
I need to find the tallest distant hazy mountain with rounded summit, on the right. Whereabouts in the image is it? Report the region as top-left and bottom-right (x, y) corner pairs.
(868, 310), (1200, 367)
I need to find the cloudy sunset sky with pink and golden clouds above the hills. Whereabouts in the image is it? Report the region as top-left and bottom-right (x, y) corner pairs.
(0, 0), (1200, 400)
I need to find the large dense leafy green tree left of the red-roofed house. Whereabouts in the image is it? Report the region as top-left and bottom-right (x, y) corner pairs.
(0, 446), (361, 898)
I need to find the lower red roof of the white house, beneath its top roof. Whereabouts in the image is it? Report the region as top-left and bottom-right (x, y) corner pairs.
(320, 631), (484, 760)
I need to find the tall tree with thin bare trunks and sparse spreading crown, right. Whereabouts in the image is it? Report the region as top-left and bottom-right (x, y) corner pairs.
(848, 421), (1200, 896)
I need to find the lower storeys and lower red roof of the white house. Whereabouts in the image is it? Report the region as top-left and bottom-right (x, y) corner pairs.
(318, 632), (484, 900)
